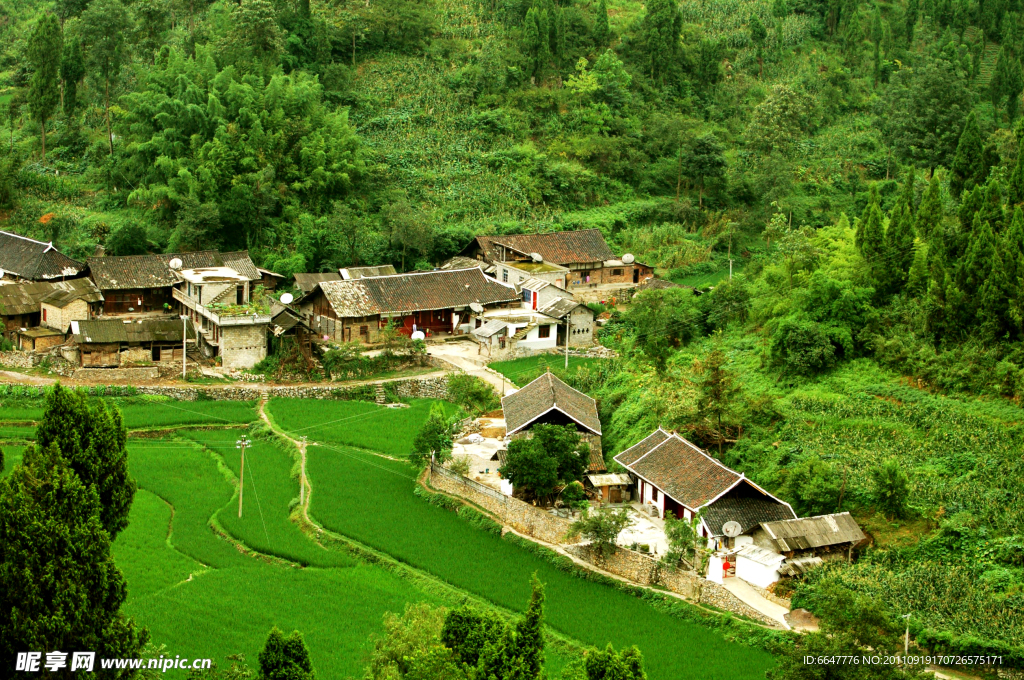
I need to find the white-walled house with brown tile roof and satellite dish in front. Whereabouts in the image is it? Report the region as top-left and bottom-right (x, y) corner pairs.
(614, 428), (797, 547)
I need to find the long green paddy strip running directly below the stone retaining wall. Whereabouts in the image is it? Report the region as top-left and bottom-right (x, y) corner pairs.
(308, 447), (771, 680)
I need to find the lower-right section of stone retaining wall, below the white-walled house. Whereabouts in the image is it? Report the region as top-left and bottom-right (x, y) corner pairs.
(565, 545), (779, 626)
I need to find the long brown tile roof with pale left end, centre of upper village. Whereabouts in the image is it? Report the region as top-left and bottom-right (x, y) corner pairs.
(319, 267), (519, 316)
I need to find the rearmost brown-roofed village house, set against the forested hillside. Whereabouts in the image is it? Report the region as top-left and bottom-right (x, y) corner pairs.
(461, 229), (654, 292)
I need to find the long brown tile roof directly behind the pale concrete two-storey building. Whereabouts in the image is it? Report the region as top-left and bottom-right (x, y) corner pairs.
(89, 250), (262, 291)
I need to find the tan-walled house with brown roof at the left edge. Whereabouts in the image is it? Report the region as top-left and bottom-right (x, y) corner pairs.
(0, 279), (103, 340)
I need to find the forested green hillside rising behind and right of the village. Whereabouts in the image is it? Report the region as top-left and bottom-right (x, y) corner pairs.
(6, 0), (1024, 660)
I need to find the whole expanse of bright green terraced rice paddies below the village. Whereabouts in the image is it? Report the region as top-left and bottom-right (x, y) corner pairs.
(0, 399), (772, 680)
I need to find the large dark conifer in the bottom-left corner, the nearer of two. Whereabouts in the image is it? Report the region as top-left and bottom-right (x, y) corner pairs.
(0, 442), (148, 663)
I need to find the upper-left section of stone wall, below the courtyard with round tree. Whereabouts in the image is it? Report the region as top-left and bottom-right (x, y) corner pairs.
(430, 466), (572, 544)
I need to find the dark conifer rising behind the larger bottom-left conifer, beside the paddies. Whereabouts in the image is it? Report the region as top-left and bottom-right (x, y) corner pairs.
(36, 383), (135, 541)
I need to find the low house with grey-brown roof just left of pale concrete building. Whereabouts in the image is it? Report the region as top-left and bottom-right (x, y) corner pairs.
(72, 317), (196, 369)
